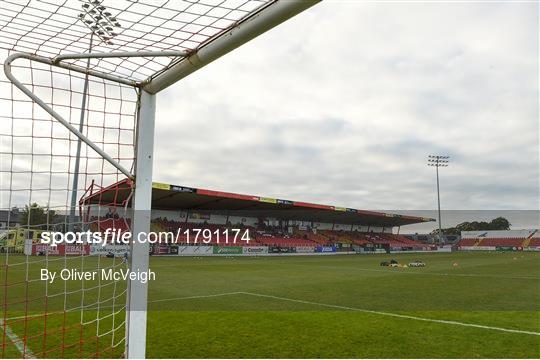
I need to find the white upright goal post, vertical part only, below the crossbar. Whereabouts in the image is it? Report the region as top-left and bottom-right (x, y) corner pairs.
(126, 90), (156, 359)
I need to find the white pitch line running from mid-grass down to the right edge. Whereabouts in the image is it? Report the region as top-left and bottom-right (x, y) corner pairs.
(241, 292), (540, 336)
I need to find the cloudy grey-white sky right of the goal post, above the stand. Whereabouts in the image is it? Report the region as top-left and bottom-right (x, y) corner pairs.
(155, 1), (539, 214)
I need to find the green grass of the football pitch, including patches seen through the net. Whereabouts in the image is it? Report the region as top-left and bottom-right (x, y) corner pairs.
(0, 253), (540, 358)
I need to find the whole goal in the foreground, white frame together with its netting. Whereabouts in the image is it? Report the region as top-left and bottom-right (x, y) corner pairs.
(0, 0), (318, 358)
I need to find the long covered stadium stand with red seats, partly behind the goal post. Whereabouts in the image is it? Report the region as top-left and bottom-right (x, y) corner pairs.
(79, 179), (434, 252)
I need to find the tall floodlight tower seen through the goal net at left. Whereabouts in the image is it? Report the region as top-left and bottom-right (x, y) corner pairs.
(69, 0), (121, 231)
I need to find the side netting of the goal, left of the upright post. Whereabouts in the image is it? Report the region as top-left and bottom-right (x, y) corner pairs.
(0, 43), (137, 358)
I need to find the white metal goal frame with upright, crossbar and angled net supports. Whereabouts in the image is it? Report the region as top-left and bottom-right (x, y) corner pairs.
(4, 0), (321, 359)
